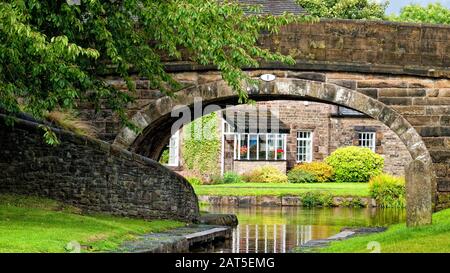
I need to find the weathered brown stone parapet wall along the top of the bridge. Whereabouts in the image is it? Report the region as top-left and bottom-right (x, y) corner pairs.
(260, 20), (450, 77)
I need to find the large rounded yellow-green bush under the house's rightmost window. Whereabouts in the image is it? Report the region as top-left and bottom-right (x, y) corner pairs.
(325, 146), (384, 182)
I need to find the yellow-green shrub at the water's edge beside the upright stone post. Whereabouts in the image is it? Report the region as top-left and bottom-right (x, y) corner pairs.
(369, 174), (406, 208)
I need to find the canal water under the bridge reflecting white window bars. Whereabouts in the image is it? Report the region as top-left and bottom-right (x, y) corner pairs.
(194, 206), (405, 253)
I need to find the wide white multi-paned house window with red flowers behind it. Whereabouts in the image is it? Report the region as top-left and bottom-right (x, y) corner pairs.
(234, 133), (287, 160)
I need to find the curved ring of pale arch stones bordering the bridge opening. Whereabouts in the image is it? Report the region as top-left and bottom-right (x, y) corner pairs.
(114, 77), (436, 225)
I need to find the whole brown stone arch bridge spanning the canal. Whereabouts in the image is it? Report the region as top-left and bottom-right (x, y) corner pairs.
(47, 20), (450, 225)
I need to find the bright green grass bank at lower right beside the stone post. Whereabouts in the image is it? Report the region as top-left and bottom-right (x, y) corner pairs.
(321, 209), (450, 253)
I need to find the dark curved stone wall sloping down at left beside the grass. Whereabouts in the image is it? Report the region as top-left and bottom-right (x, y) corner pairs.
(0, 116), (199, 221)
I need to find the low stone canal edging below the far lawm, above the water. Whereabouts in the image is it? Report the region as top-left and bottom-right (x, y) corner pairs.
(198, 195), (377, 207)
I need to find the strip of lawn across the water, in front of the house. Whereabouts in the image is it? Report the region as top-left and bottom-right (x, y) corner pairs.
(194, 183), (369, 197)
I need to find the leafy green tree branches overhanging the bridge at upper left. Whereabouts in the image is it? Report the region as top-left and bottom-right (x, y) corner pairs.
(0, 0), (306, 142)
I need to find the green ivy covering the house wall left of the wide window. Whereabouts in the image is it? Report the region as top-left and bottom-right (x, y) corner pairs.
(182, 113), (220, 178)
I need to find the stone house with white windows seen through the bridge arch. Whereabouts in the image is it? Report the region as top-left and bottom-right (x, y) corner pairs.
(164, 101), (411, 175)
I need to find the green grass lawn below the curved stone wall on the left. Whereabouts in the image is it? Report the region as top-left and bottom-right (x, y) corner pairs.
(0, 195), (184, 253)
